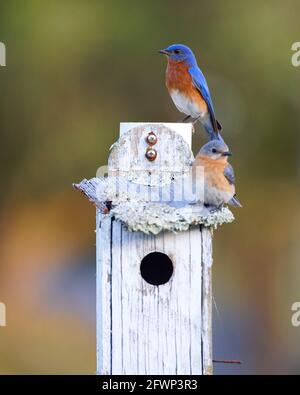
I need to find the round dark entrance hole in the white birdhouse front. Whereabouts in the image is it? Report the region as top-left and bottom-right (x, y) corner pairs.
(141, 252), (173, 285)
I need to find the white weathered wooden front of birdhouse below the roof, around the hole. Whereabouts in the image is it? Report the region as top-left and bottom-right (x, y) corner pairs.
(97, 214), (212, 375)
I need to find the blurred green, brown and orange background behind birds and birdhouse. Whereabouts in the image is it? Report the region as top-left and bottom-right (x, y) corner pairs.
(0, 0), (300, 374)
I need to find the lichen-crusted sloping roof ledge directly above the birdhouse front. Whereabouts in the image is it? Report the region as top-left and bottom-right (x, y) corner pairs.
(74, 177), (234, 235)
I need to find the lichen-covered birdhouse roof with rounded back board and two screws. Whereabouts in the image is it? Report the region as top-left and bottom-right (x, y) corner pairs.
(74, 123), (234, 234)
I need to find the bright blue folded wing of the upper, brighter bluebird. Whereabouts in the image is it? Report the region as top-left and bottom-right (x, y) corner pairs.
(189, 66), (222, 133)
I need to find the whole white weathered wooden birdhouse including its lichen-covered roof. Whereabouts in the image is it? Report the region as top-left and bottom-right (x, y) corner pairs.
(75, 123), (233, 375)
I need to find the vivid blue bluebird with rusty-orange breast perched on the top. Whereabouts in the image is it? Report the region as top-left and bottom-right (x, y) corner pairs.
(159, 44), (222, 140)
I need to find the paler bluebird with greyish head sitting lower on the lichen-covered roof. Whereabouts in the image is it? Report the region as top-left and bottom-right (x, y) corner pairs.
(192, 140), (242, 208)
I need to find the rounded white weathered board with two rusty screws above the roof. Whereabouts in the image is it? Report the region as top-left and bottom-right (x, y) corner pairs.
(108, 123), (194, 186)
